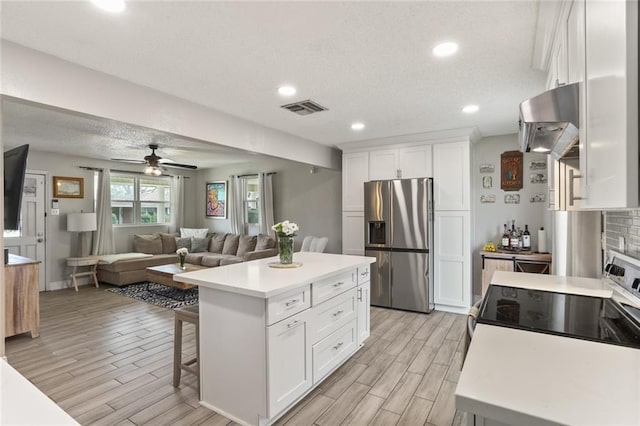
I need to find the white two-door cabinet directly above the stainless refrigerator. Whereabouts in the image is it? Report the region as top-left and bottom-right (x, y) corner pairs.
(369, 145), (433, 180)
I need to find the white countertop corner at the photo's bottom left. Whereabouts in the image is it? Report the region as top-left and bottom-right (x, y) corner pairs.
(0, 358), (79, 425)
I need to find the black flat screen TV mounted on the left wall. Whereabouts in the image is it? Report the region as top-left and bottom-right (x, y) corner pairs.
(4, 145), (29, 230)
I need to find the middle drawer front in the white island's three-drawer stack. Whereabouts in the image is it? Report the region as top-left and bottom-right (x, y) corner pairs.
(311, 287), (357, 343)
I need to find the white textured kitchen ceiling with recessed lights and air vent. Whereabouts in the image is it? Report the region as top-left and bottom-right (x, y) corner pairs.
(1, 0), (545, 162)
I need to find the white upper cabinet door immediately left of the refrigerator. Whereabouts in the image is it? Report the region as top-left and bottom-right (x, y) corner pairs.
(342, 152), (369, 211)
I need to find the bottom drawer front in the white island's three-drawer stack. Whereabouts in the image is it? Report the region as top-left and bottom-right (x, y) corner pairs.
(311, 318), (356, 384)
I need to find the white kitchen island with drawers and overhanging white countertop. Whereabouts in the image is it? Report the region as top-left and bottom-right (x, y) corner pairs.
(175, 252), (375, 425)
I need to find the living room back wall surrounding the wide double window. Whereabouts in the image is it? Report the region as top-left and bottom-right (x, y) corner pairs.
(27, 150), (196, 289)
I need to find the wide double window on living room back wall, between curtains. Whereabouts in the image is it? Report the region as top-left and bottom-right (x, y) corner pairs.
(111, 174), (171, 225)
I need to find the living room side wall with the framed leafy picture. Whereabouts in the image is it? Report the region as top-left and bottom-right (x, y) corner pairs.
(194, 158), (342, 253)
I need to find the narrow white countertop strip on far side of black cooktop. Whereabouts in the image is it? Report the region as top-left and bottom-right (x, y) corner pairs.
(491, 271), (613, 297)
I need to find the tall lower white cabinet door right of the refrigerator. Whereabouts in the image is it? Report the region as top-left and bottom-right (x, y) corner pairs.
(434, 211), (471, 313)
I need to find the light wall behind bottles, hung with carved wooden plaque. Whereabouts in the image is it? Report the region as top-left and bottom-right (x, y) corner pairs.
(471, 134), (551, 297)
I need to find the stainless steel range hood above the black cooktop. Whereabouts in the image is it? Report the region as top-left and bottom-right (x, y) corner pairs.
(519, 83), (580, 159)
